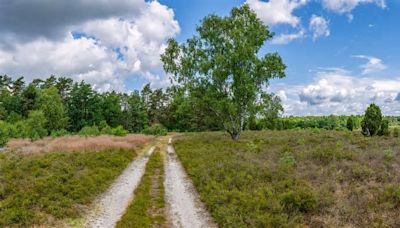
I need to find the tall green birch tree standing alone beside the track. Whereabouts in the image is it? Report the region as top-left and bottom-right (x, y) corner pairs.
(161, 5), (286, 140)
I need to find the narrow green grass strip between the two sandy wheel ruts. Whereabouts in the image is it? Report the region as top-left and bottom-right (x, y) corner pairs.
(117, 147), (166, 228)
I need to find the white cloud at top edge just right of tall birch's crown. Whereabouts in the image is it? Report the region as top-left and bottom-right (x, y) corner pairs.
(246, 0), (308, 27)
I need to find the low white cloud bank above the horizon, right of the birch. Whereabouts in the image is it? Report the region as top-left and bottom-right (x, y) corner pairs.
(271, 68), (400, 115)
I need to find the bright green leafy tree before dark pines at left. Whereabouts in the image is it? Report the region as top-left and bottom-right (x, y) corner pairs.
(38, 87), (68, 132)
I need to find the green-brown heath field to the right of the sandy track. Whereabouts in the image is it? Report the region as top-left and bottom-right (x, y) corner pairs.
(174, 130), (400, 227)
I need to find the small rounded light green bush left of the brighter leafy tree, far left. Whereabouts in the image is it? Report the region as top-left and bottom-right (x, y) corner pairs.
(25, 111), (48, 140)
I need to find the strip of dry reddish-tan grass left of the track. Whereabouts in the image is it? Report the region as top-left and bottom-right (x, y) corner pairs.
(7, 134), (154, 154)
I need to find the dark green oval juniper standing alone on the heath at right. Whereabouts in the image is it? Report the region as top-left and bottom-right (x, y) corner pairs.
(361, 104), (382, 136)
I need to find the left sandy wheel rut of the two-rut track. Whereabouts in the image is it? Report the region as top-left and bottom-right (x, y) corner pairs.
(85, 146), (155, 228)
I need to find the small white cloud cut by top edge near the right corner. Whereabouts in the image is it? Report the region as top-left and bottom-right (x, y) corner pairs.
(322, 0), (386, 14)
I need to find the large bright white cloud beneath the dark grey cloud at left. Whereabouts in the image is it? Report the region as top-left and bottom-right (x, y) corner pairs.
(0, 0), (180, 90)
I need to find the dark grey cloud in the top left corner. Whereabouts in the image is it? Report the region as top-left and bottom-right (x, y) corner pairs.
(0, 0), (146, 42)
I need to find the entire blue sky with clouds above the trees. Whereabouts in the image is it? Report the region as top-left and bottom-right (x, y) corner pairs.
(0, 0), (400, 115)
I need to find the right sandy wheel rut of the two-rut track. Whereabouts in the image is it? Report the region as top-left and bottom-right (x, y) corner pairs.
(164, 139), (217, 228)
